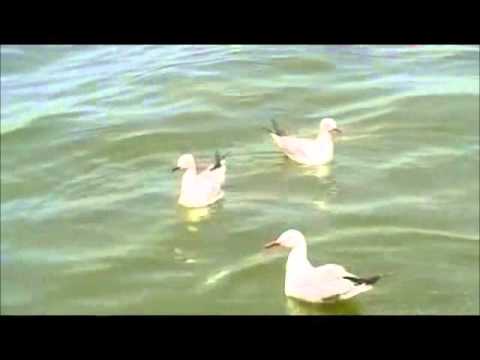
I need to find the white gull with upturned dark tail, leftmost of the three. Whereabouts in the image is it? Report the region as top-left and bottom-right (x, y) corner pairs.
(172, 152), (226, 208)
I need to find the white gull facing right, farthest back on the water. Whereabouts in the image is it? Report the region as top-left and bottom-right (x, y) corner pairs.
(267, 118), (342, 166)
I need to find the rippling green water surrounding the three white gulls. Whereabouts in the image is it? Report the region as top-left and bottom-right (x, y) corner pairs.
(0, 45), (480, 315)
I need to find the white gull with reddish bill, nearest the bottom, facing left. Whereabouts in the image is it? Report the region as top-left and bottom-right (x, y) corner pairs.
(265, 229), (380, 303)
